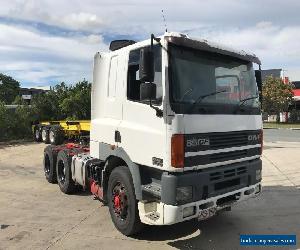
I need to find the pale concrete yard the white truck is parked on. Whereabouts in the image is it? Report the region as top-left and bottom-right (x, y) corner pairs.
(0, 142), (300, 250)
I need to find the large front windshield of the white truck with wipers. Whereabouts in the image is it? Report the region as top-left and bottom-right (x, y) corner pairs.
(169, 45), (260, 114)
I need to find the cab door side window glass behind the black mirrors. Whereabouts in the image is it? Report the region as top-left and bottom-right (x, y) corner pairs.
(127, 46), (162, 104)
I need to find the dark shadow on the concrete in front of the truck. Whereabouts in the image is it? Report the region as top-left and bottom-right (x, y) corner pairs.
(136, 186), (300, 249)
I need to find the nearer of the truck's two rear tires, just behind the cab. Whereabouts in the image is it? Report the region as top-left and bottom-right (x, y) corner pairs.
(56, 150), (76, 194)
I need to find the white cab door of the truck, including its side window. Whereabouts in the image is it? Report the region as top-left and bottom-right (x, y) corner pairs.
(119, 46), (166, 168)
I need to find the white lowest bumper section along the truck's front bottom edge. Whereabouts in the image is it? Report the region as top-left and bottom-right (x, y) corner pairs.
(138, 182), (261, 225)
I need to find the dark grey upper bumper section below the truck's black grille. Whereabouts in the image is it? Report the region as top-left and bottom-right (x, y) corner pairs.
(160, 159), (262, 206)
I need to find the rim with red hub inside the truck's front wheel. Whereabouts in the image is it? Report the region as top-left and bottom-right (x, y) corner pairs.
(111, 182), (129, 220)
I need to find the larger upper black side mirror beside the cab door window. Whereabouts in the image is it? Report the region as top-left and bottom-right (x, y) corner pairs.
(139, 48), (154, 82)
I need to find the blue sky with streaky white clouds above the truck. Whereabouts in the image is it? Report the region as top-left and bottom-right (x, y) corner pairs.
(0, 0), (300, 87)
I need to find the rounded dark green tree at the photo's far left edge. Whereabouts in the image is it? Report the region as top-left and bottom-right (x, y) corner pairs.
(0, 73), (20, 104)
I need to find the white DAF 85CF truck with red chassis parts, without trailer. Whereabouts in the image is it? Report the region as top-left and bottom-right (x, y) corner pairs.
(44, 33), (263, 235)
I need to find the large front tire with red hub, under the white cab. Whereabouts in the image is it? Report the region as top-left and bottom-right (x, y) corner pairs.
(107, 166), (143, 236)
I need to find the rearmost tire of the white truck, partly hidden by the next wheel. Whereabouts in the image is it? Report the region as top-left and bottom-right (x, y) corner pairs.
(43, 145), (57, 183)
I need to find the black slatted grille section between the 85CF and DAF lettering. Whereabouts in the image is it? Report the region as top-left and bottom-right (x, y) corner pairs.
(209, 131), (248, 149)
